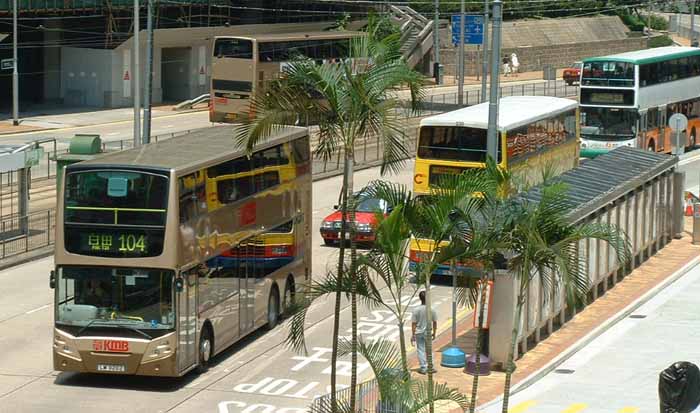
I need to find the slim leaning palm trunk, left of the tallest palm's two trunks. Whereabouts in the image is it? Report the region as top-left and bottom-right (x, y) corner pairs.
(331, 156), (348, 413)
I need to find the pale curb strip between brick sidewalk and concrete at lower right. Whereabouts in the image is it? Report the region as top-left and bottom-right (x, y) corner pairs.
(477, 256), (700, 409)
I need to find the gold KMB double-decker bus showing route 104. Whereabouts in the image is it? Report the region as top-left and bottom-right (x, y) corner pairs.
(51, 126), (311, 376)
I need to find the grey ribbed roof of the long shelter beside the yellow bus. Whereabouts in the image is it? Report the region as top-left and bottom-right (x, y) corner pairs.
(521, 146), (678, 223)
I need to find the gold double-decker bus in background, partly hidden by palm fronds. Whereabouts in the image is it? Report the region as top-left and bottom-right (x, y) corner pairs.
(209, 31), (366, 122)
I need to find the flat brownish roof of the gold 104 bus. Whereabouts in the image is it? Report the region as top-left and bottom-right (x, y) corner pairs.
(74, 125), (307, 173)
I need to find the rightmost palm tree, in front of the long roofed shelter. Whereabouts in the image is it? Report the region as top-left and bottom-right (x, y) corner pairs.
(502, 184), (630, 413)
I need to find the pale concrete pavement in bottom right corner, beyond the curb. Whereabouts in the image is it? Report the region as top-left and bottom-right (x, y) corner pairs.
(482, 260), (700, 413)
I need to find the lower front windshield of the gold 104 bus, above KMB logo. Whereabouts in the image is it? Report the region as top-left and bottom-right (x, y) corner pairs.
(56, 266), (175, 330)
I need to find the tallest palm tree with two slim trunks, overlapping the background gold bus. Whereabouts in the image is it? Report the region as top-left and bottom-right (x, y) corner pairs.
(236, 28), (423, 408)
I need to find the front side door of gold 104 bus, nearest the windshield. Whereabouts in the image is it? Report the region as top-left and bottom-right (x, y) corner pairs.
(176, 268), (197, 372)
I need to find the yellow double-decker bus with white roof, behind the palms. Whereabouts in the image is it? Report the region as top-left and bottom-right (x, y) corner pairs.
(410, 96), (579, 274)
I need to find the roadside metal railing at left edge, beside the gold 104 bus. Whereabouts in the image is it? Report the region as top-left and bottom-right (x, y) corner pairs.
(0, 210), (56, 259)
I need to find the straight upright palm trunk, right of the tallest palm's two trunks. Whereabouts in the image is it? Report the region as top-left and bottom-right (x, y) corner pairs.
(345, 153), (357, 412)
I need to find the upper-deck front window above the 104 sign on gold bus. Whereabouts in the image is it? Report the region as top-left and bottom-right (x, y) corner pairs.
(65, 170), (168, 226)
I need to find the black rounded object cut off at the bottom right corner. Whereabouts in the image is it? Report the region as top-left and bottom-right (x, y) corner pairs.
(659, 361), (700, 413)
